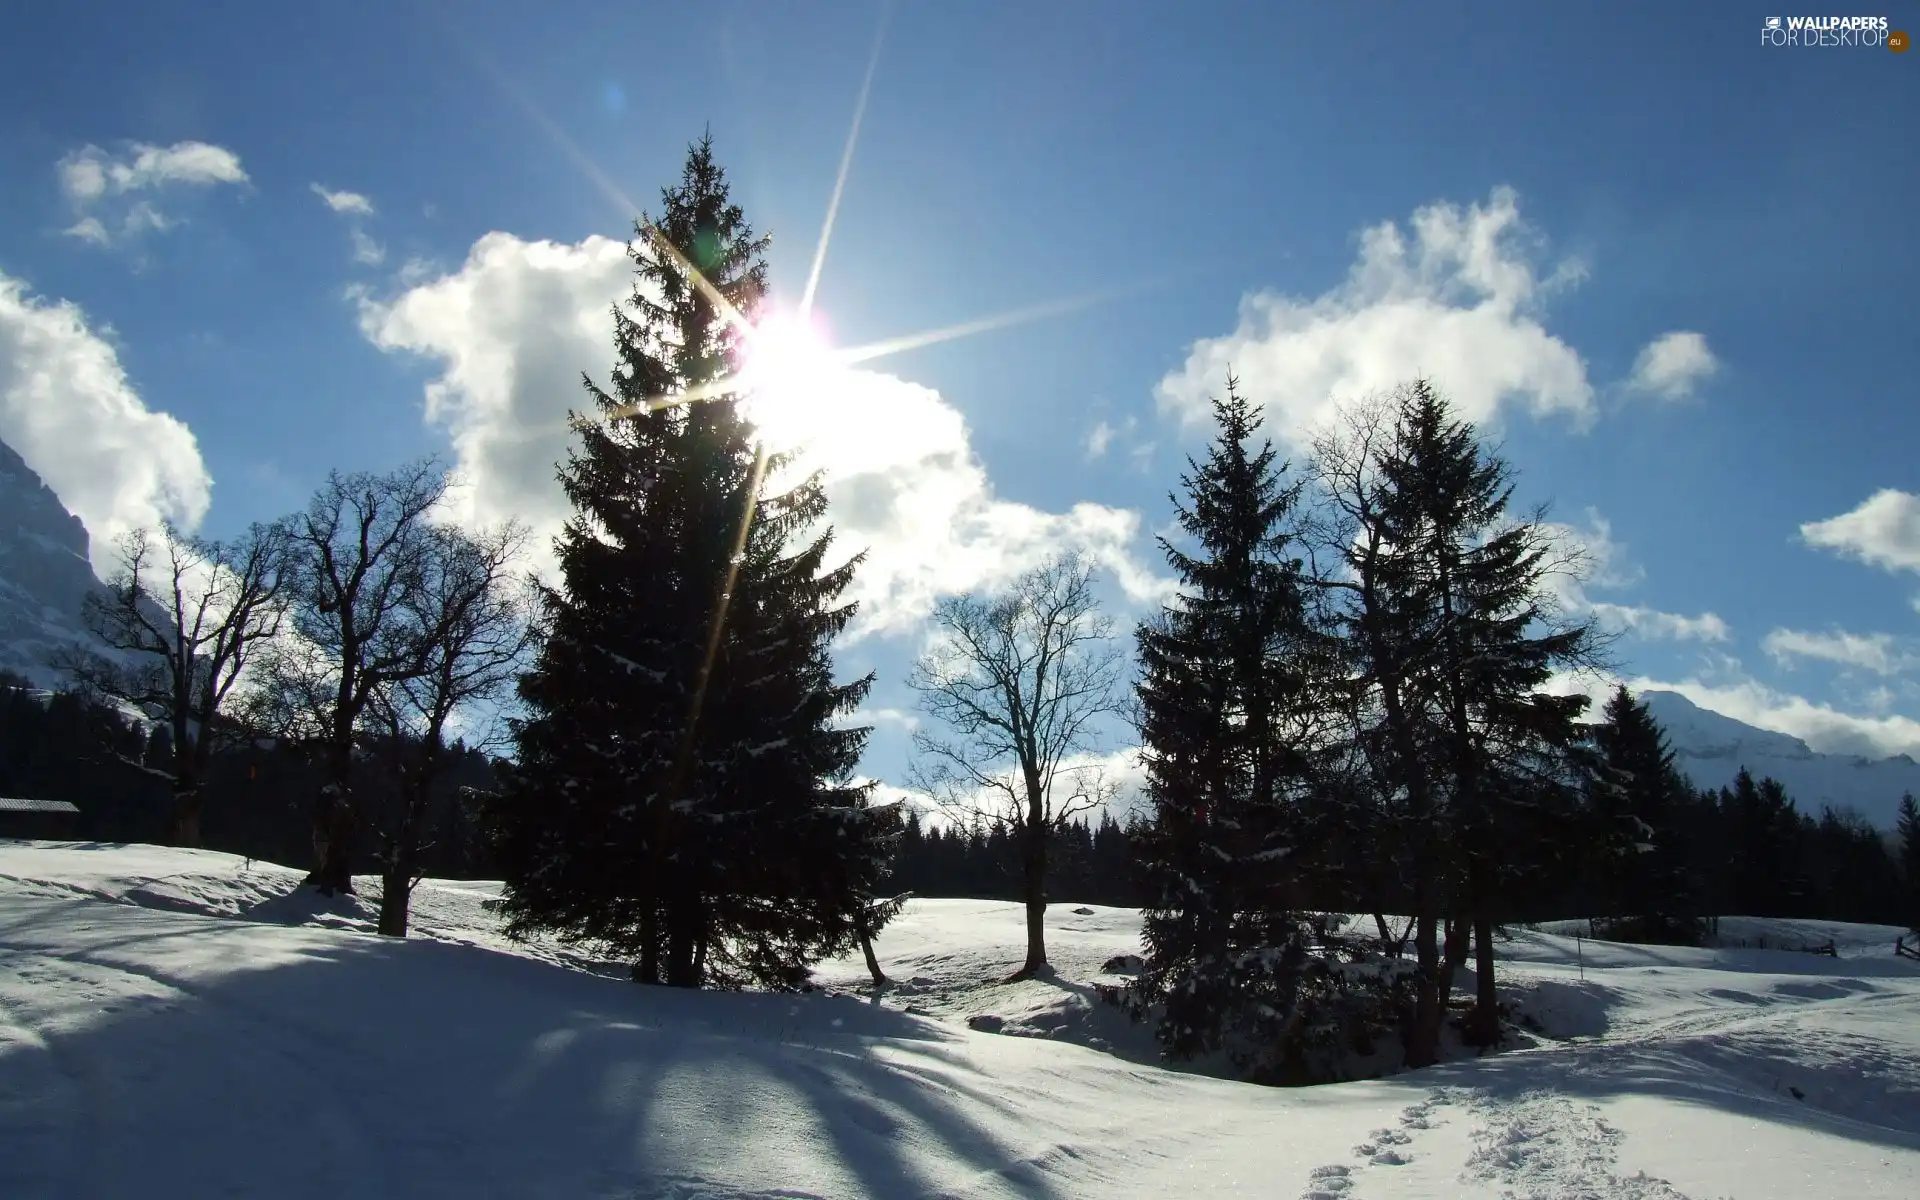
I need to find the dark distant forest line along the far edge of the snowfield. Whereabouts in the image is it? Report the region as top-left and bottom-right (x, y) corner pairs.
(0, 674), (1907, 924)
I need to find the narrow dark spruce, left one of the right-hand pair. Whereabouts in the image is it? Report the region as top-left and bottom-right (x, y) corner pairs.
(1137, 378), (1321, 1068)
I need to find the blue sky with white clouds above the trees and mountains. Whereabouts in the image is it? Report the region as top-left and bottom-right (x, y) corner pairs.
(0, 0), (1920, 794)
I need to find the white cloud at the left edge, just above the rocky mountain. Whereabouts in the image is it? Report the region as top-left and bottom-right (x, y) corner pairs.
(0, 273), (213, 572)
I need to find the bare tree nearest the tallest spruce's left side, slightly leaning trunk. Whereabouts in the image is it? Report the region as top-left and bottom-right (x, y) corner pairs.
(369, 524), (534, 937)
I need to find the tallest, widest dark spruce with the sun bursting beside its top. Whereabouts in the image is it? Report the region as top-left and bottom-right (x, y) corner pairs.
(490, 138), (897, 987)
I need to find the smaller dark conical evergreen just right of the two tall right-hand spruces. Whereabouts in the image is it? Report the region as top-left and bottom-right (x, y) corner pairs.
(1590, 685), (1699, 945)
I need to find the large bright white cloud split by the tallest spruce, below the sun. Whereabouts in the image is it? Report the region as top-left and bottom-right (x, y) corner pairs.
(361, 232), (1167, 641)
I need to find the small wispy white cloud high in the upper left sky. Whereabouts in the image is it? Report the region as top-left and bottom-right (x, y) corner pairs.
(56, 142), (248, 246)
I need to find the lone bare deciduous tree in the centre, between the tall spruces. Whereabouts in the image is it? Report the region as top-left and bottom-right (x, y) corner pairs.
(908, 553), (1125, 979)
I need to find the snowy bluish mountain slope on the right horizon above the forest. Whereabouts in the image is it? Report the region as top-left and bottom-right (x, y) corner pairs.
(1640, 691), (1920, 829)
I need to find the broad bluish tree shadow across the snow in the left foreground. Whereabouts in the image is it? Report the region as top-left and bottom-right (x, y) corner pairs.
(0, 899), (1060, 1200)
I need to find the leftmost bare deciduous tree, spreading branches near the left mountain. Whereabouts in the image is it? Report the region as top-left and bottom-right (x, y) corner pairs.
(65, 524), (288, 847)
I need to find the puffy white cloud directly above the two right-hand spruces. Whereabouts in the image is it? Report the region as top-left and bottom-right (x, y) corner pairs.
(1158, 188), (1594, 445)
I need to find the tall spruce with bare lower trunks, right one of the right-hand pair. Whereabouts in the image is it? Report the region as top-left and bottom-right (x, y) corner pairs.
(1321, 380), (1596, 1066)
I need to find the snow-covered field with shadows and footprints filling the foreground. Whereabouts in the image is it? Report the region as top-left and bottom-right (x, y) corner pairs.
(0, 841), (1920, 1200)
